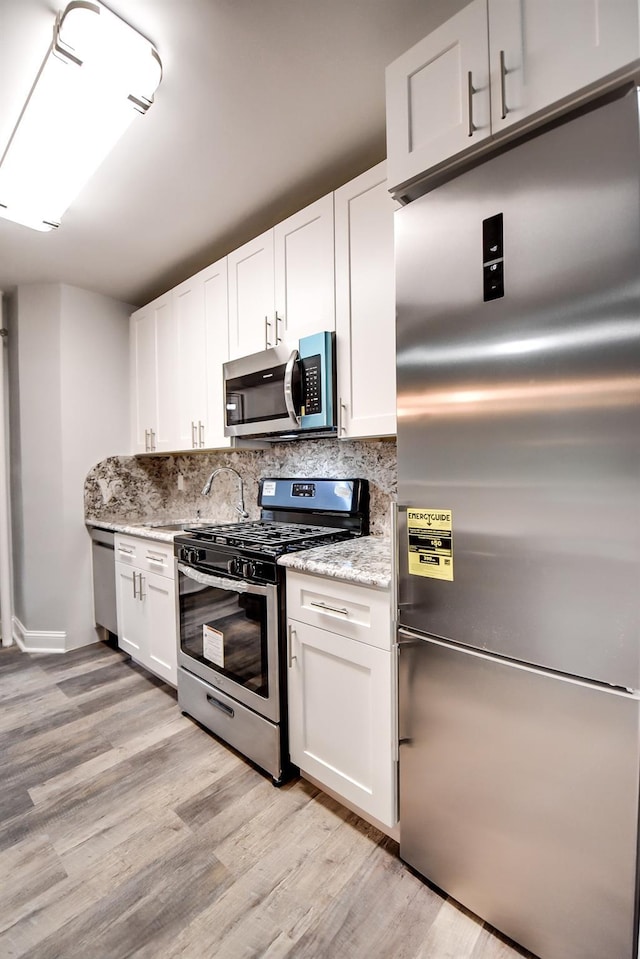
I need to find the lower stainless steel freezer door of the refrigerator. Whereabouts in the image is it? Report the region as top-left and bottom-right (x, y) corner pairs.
(400, 636), (639, 959)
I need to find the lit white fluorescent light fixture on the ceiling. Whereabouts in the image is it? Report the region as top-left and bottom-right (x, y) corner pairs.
(0, 0), (162, 230)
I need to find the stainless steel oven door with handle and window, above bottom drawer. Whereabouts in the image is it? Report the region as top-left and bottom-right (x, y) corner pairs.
(178, 563), (280, 722)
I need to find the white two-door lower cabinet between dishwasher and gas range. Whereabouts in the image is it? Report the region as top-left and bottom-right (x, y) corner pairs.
(115, 534), (178, 686)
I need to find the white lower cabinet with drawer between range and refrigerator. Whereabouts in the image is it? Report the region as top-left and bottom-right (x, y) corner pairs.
(287, 570), (397, 827)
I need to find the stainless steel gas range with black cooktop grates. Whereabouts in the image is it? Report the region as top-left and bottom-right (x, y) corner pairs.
(175, 477), (369, 785)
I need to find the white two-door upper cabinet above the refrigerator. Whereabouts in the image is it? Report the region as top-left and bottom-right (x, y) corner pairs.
(387, 0), (640, 190)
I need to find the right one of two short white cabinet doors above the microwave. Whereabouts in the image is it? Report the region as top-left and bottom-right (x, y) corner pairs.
(274, 193), (336, 349)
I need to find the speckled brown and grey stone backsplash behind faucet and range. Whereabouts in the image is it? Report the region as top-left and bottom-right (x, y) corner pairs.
(84, 440), (397, 536)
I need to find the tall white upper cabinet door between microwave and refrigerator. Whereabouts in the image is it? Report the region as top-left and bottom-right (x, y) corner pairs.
(335, 163), (396, 438)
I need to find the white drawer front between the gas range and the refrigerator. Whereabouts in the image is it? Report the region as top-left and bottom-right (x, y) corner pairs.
(287, 570), (391, 649)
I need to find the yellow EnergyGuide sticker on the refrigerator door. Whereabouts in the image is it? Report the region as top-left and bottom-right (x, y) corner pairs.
(407, 507), (453, 582)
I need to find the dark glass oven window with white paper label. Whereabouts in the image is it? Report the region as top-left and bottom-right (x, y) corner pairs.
(180, 576), (269, 699)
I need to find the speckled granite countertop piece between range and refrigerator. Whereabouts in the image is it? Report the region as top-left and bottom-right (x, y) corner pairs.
(278, 536), (391, 589)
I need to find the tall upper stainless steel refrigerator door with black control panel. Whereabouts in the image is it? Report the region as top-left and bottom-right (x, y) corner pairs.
(396, 86), (640, 689)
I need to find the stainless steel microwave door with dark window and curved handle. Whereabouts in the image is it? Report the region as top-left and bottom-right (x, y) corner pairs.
(223, 346), (301, 436)
